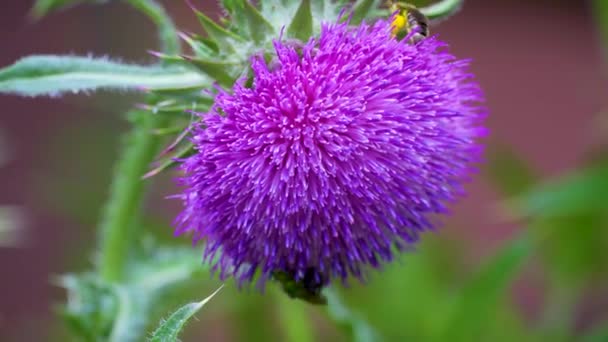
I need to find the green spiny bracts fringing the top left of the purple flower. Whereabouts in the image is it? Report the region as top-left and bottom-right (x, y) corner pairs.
(140, 0), (386, 177)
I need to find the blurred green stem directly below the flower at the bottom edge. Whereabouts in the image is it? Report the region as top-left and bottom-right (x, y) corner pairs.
(275, 291), (315, 342)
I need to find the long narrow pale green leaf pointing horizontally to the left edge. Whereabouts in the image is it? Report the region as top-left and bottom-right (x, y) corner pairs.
(0, 56), (210, 96)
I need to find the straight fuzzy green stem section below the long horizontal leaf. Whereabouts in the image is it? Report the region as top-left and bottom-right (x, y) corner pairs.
(98, 113), (167, 282)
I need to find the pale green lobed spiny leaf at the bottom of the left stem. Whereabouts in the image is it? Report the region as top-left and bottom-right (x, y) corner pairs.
(57, 246), (207, 342)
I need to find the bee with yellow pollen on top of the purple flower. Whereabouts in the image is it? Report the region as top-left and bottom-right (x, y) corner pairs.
(388, 1), (430, 44)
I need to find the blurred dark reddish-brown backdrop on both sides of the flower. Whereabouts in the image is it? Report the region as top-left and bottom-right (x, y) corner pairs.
(0, 0), (608, 340)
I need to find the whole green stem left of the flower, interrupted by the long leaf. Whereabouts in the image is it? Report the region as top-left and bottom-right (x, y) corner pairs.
(98, 0), (180, 282)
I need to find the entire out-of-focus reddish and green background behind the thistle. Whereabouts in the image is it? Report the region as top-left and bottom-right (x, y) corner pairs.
(0, 0), (608, 341)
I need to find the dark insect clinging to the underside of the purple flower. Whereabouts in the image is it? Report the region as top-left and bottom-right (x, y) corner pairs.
(272, 267), (327, 305)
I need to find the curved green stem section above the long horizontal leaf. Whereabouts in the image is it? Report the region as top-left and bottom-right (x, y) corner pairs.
(125, 0), (180, 55)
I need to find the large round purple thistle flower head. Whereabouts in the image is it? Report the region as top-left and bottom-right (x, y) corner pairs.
(176, 20), (485, 284)
